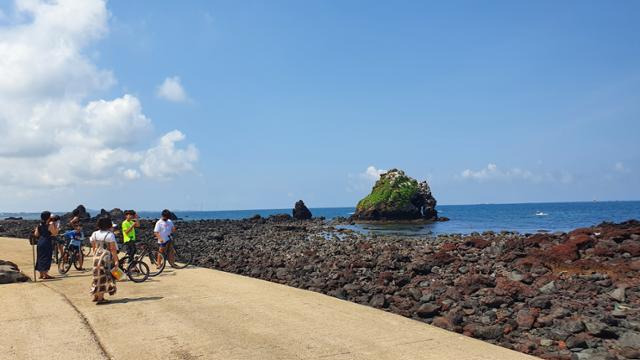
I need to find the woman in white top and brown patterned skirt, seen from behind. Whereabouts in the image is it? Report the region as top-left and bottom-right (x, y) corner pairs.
(90, 217), (118, 304)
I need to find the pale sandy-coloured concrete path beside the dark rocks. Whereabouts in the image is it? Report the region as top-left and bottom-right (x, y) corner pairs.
(0, 238), (534, 360)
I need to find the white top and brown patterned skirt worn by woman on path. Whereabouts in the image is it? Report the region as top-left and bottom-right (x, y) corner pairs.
(91, 230), (117, 296)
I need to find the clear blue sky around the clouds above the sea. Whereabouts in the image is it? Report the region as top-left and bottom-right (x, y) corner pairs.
(0, 1), (640, 210)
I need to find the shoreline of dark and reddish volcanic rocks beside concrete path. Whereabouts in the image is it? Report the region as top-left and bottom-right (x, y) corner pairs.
(0, 215), (640, 359)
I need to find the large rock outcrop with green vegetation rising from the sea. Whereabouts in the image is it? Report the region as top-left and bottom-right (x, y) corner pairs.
(352, 169), (438, 221)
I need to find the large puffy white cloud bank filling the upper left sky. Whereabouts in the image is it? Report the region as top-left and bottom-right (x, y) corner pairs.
(0, 0), (197, 192)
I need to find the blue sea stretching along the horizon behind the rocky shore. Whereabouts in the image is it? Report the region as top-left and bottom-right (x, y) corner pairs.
(0, 201), (640, 235)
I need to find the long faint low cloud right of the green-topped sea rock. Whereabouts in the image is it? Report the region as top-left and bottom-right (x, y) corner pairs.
(460, 163), (573, 184)
